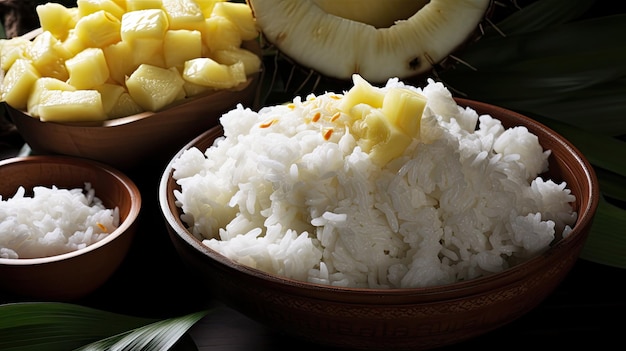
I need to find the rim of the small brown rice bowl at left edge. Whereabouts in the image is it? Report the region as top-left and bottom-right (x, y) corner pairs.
(0, 155), (142, 266)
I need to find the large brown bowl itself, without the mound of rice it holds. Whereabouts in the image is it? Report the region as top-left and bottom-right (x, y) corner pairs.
(159, 99), (599, 350)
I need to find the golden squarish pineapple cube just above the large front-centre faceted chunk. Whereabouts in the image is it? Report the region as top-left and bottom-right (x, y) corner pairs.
(163, 29), (204, 68)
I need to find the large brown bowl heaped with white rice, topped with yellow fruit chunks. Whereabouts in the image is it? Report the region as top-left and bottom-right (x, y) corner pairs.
(159, 76), (599, 350)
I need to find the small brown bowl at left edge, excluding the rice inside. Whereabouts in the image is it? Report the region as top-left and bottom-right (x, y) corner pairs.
(0, 156), (141, 301)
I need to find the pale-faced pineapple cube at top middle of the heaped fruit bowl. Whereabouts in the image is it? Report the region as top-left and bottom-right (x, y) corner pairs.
(120, 9), (169, 44)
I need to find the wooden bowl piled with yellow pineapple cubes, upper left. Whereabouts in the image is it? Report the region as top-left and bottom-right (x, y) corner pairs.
(0, 1), (261, 169)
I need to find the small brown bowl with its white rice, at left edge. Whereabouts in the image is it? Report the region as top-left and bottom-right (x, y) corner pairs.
(0, 156), (141, 301)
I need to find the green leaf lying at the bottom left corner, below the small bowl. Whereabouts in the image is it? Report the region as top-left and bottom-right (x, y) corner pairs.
(0, 302), (208, 351)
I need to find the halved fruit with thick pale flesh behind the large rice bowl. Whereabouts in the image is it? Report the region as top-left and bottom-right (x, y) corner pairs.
(248, 0), (491, 82)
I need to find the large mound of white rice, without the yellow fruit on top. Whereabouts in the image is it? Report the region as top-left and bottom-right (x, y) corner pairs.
(168, 79), (577, 288)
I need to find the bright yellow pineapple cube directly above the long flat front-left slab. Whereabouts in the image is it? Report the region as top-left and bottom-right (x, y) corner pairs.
(65, 48), (109, 89)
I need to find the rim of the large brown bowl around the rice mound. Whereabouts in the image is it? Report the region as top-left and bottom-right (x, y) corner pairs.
(158, 97), (600, 296)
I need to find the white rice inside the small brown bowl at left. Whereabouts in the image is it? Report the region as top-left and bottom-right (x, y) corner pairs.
(0, 183), (119, 259)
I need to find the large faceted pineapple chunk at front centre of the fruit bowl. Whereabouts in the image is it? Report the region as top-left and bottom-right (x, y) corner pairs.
(126, 64), (185, 111)
